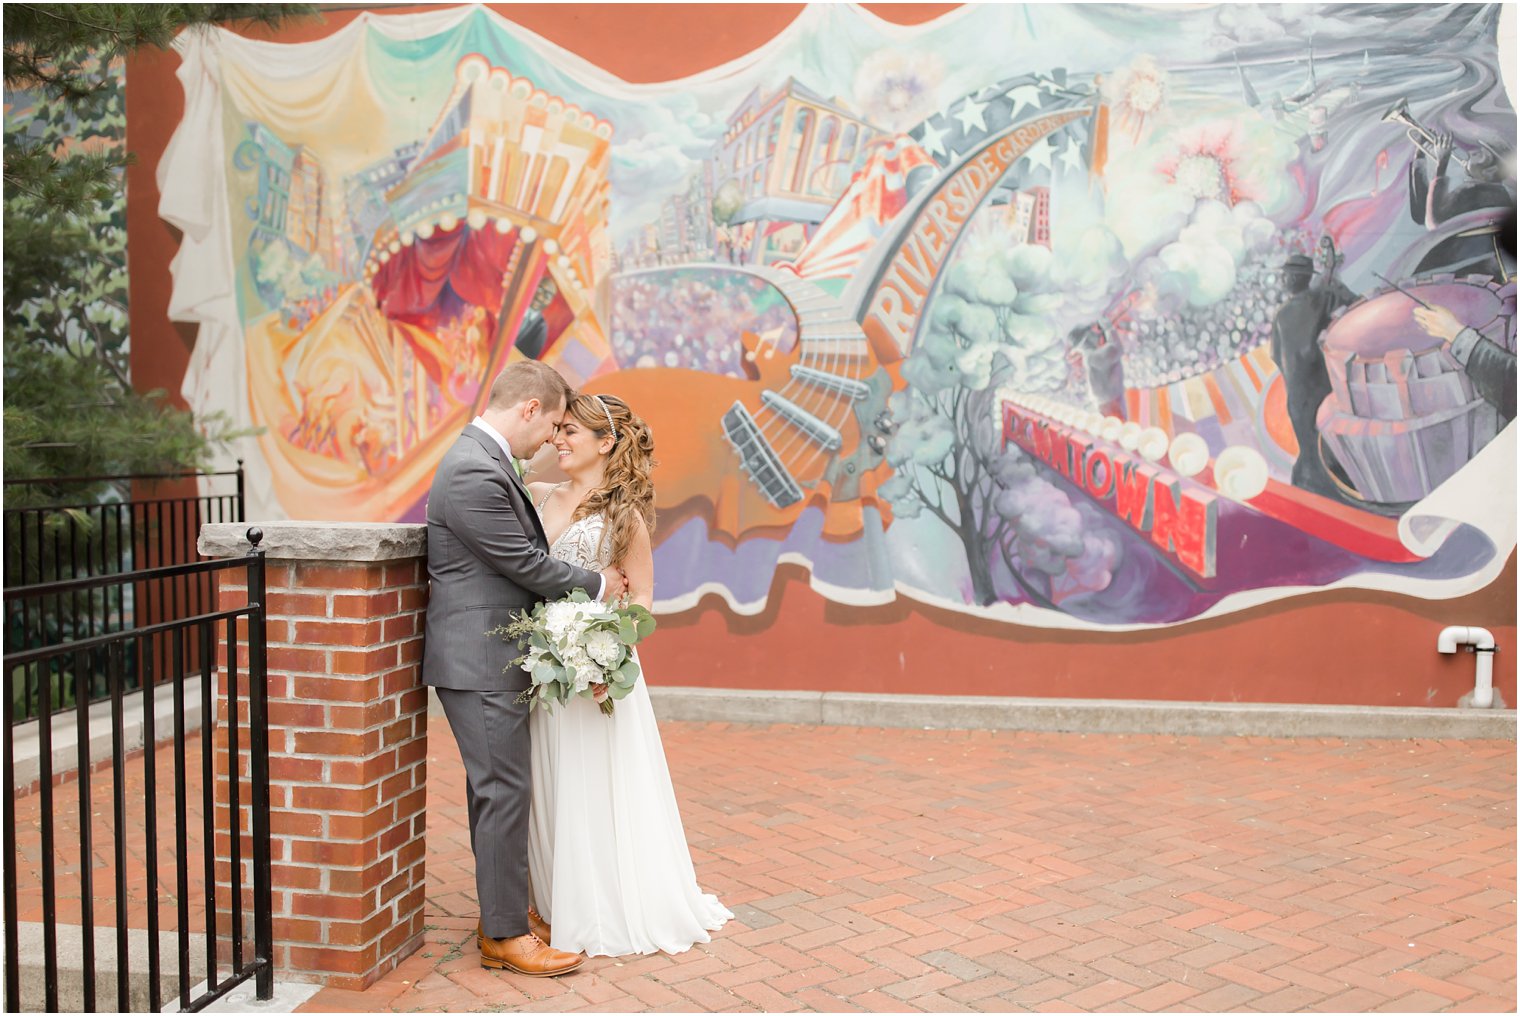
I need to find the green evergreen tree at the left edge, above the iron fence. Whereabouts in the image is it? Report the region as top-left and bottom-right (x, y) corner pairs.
(3, 3), (313, 505)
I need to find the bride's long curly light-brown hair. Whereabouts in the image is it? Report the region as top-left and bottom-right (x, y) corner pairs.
(565, 392), (658, 564)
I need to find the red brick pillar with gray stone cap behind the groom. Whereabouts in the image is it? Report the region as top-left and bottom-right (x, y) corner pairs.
(199, 522), (427, 989)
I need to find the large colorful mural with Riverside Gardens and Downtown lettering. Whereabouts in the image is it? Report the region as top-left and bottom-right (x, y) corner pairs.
(161, 5), (1515, 627)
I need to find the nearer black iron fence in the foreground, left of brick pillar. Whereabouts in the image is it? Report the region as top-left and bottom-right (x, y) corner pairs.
(0, 529), (274, 1011)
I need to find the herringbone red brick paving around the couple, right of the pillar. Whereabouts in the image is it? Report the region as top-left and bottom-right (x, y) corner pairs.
(293, 721), (1515, 1011)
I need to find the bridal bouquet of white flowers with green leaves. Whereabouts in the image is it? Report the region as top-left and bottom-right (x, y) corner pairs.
(486, 589), (655, 716)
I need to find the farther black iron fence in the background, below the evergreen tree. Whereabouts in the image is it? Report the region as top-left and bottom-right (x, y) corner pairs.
(3, 462), (245, 722)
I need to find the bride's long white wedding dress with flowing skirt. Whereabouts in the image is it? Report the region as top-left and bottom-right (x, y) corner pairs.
(527, 514), (733, 957)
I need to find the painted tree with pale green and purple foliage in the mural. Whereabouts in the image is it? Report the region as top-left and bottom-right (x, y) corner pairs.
(882, 245), (1120, 608)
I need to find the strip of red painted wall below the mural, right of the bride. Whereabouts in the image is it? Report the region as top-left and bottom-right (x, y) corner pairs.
(640, 557), (1515, 707)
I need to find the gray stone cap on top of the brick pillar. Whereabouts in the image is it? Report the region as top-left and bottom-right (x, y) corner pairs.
(196, 520), (427, 561)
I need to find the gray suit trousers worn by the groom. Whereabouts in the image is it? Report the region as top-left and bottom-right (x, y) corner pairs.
(435, 687), (534, 938)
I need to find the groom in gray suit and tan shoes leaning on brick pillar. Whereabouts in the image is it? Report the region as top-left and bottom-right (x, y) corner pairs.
(423, 360), (628, 976)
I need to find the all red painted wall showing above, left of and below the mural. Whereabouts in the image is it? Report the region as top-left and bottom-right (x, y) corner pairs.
(126, 5), (1515, 706)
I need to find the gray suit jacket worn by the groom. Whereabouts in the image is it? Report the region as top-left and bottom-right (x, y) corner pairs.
(423, 426), (602, 691)
